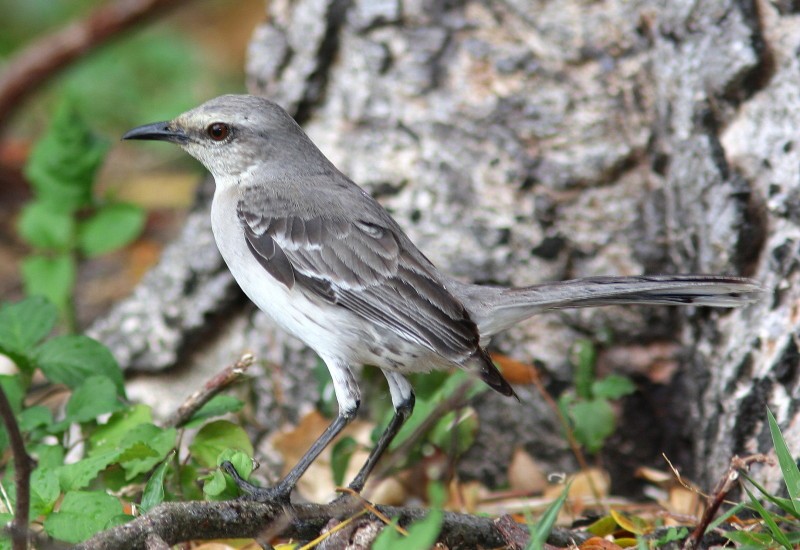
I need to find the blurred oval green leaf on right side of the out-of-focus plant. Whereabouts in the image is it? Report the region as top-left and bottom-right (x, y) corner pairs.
(78, 203), (145, 257)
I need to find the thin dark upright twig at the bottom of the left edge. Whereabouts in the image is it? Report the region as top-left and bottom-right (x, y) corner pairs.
(0, 388), (33, 550)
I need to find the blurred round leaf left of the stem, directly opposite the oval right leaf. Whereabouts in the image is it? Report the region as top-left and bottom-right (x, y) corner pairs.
(17, 201), (75, 252)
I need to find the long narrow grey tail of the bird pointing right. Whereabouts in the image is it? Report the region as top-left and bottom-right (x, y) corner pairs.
(453, 275), (762, 337)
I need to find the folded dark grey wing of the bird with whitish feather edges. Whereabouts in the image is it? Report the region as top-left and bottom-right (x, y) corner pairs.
(237, 195), (480, 362)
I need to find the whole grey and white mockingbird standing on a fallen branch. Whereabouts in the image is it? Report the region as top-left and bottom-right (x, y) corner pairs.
(123, 95), (759, 500)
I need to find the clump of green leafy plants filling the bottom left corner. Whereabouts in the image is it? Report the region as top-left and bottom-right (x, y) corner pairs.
(0, 297), (254, 550)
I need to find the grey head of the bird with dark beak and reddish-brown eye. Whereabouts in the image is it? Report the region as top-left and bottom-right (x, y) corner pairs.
(122, 95), (328, 185)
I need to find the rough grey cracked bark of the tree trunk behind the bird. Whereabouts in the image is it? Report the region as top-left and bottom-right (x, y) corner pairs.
(93, 0), (800, 496)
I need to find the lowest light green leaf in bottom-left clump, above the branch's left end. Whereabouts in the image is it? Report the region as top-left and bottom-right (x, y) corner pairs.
(44, 491), (122, 544)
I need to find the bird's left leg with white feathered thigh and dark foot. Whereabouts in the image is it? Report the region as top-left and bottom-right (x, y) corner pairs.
(222, 363), (361, 502)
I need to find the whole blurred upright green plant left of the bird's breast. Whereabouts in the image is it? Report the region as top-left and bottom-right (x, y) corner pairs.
(17, 100), (145, 330)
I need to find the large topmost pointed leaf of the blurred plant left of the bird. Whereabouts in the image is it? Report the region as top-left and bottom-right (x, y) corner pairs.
(25, 100), (108, 211)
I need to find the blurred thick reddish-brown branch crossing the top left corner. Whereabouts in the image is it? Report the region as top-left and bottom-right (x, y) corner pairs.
(0, 0), (192, 126)
